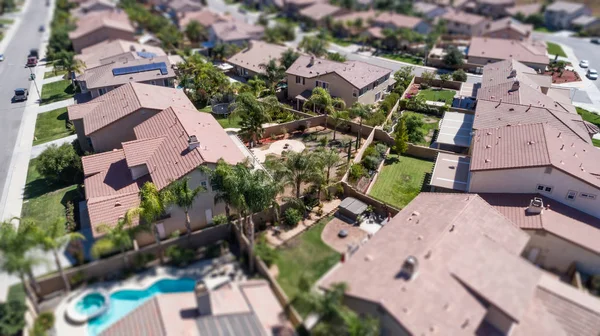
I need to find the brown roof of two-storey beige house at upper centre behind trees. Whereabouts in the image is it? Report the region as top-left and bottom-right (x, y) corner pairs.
(286, 55), (392, 89)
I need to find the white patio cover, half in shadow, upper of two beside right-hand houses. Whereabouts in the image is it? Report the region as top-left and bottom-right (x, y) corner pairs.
(436, 112), (475, 147)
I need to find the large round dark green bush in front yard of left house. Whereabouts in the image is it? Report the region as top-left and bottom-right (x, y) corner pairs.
(37, 144), (83, 184)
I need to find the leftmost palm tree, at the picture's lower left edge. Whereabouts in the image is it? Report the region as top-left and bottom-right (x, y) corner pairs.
(0, 221), (40, 312)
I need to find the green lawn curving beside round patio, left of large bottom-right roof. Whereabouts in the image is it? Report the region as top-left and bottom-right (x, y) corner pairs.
(276, 217), (340, 315)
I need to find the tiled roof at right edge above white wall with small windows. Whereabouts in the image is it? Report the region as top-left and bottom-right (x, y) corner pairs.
(471, 124), (600, 187)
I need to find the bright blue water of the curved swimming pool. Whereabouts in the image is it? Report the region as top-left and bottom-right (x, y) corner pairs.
(84, 278), (196, 336)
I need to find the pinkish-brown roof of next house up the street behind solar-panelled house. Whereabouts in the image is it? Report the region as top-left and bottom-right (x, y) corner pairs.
(69, 9), (135, 39)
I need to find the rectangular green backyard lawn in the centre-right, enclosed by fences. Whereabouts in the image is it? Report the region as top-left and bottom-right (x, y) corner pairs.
(369, 154), (433, 209)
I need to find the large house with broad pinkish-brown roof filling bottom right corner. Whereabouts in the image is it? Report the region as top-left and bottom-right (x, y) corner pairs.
(318, 193), (600, 336)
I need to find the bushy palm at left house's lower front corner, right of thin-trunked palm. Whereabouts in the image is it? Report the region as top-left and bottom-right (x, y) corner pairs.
(92, 216), (133, 267)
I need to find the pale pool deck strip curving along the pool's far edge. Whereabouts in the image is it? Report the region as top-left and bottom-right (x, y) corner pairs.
(54, 255), (246, 336)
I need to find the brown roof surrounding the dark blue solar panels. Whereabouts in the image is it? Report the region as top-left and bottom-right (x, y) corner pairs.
(77, 56), (176, 89)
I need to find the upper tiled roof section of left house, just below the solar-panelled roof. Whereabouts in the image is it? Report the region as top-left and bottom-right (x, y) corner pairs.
(67, 83), (194, 135)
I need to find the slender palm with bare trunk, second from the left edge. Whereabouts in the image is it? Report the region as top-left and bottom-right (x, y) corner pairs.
(35, 220), (85, 293)
